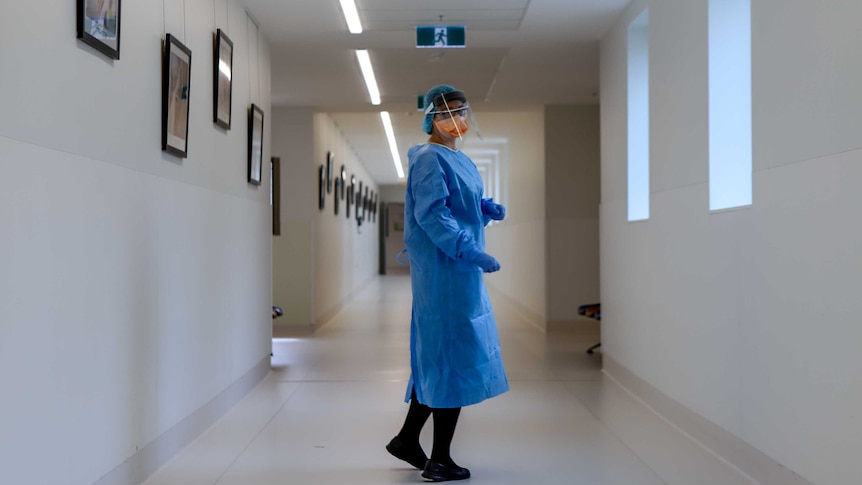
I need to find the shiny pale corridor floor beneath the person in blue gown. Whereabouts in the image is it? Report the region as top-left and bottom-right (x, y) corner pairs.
(145, 276), (753, 485)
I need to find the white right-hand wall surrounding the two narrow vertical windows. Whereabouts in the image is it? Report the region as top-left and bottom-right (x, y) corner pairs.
(601, 0), (862, 485)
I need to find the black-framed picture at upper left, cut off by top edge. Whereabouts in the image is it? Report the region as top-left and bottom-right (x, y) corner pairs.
(76, 0), (120, 59)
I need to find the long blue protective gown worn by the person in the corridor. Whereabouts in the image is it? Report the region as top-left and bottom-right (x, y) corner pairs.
(404, 143), (509, 408)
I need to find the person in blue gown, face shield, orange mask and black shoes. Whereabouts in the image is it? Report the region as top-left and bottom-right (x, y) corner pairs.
(386, 85), (509, 482)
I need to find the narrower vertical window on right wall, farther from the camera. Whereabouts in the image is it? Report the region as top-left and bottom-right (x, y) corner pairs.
(628, 10), (649, 221)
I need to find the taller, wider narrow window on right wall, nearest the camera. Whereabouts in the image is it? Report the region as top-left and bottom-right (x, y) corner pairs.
(709, 0), (752, 210)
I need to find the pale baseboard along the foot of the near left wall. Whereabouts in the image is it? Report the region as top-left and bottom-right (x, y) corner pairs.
(93, 356), (270, 485)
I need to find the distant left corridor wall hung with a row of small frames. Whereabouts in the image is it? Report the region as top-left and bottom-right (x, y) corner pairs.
(272, 107), (380, 330)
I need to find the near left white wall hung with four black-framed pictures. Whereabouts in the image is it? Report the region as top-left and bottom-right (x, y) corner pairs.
(0, 0), (271, 485)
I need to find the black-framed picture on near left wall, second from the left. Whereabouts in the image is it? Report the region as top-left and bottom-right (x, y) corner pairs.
(162, 34), (192, 158)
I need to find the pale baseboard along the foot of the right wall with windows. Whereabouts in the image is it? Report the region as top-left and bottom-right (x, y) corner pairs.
(602, 354), (813, 485)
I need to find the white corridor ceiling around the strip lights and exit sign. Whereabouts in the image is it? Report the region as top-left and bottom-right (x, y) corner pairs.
(245, 0), (630, 184)
